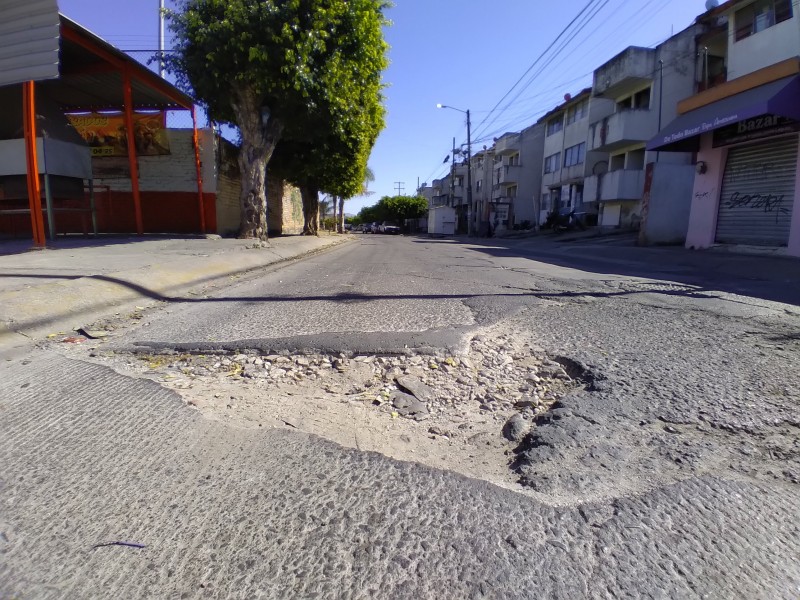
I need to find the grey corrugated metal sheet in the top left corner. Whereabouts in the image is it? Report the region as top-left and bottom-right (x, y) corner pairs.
(0, 0), (59, 86)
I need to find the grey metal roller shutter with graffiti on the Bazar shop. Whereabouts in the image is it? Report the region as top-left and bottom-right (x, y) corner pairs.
(717, 135), (798, 246)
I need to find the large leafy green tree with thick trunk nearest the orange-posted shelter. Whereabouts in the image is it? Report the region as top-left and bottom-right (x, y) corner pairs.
(167, 0), (387, 240)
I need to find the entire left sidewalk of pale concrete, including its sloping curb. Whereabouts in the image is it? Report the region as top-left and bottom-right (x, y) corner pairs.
(0, 234), (350, 350)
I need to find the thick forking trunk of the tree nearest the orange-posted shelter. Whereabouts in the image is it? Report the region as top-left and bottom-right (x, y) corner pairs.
(231, 89), (283, 242)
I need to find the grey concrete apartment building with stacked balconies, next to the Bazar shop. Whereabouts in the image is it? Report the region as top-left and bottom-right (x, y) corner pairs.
(584, 25), (699, 232)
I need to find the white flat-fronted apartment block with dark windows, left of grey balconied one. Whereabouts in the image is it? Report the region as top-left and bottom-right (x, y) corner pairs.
(537, 88), (614, 223)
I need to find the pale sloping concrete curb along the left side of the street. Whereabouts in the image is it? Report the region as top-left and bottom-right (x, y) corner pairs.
(0, 236), (351, 350)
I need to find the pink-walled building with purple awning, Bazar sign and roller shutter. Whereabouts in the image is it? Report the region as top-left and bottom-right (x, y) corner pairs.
(647, 0), (800, 256)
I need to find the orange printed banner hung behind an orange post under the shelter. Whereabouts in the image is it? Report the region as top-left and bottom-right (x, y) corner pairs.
(67, 113), (170, 156)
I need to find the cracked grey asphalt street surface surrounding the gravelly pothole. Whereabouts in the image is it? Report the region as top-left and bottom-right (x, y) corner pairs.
(0, 236), (800, 598)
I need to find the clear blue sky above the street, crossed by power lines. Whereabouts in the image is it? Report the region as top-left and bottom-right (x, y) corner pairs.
(58, 0), (705, 213)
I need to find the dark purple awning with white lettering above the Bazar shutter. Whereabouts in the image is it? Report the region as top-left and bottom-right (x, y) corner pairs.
(647, 75), (800, 152)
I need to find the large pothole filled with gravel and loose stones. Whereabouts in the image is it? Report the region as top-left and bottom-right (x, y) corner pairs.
(61, 329), (593, 491)
